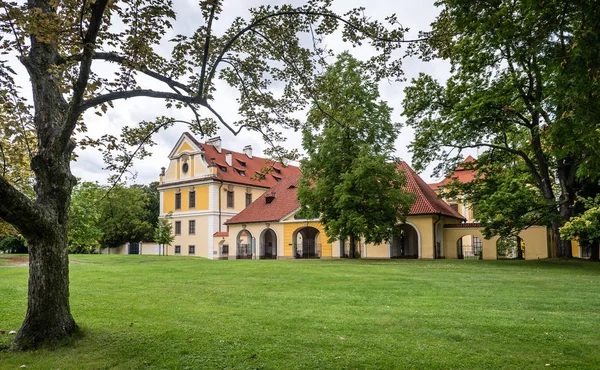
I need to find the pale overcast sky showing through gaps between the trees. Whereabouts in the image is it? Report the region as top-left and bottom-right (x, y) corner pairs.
(67, 0), (448, 184)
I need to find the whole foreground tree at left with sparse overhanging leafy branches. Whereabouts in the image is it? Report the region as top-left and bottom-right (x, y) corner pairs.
(0, 0), (405, 348)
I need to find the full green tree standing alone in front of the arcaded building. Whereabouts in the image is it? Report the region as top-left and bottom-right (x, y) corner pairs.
(298, 53), (412, 258)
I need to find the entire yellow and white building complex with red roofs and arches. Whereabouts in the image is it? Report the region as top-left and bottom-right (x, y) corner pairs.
(159, 133), (549, 259)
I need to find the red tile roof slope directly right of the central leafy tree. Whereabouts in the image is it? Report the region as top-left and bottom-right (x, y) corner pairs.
(397, 162), (465, 220)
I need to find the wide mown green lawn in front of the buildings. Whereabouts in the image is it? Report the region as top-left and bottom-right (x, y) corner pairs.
(0, 256), (600, 370)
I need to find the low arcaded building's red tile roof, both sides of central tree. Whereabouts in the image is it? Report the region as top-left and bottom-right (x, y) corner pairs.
(226, 162), (464, 225)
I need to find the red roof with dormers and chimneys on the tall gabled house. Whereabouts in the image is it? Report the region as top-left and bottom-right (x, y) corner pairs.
(184, 132), (300, 188)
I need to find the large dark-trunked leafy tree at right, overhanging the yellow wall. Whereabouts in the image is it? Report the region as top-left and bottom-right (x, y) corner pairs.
(404, 0), (600, 257)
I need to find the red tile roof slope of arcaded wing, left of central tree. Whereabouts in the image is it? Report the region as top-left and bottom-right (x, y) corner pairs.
(225, 174), (301, 225)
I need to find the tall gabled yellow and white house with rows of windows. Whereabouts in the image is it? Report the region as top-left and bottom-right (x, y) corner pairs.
(158, 133), (300, 258)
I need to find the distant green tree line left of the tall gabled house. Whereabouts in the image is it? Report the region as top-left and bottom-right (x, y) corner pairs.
(0, 182), (160, 253)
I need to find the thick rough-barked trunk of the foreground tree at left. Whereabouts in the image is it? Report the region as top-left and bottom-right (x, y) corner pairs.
(13, 20), (76, 349)
